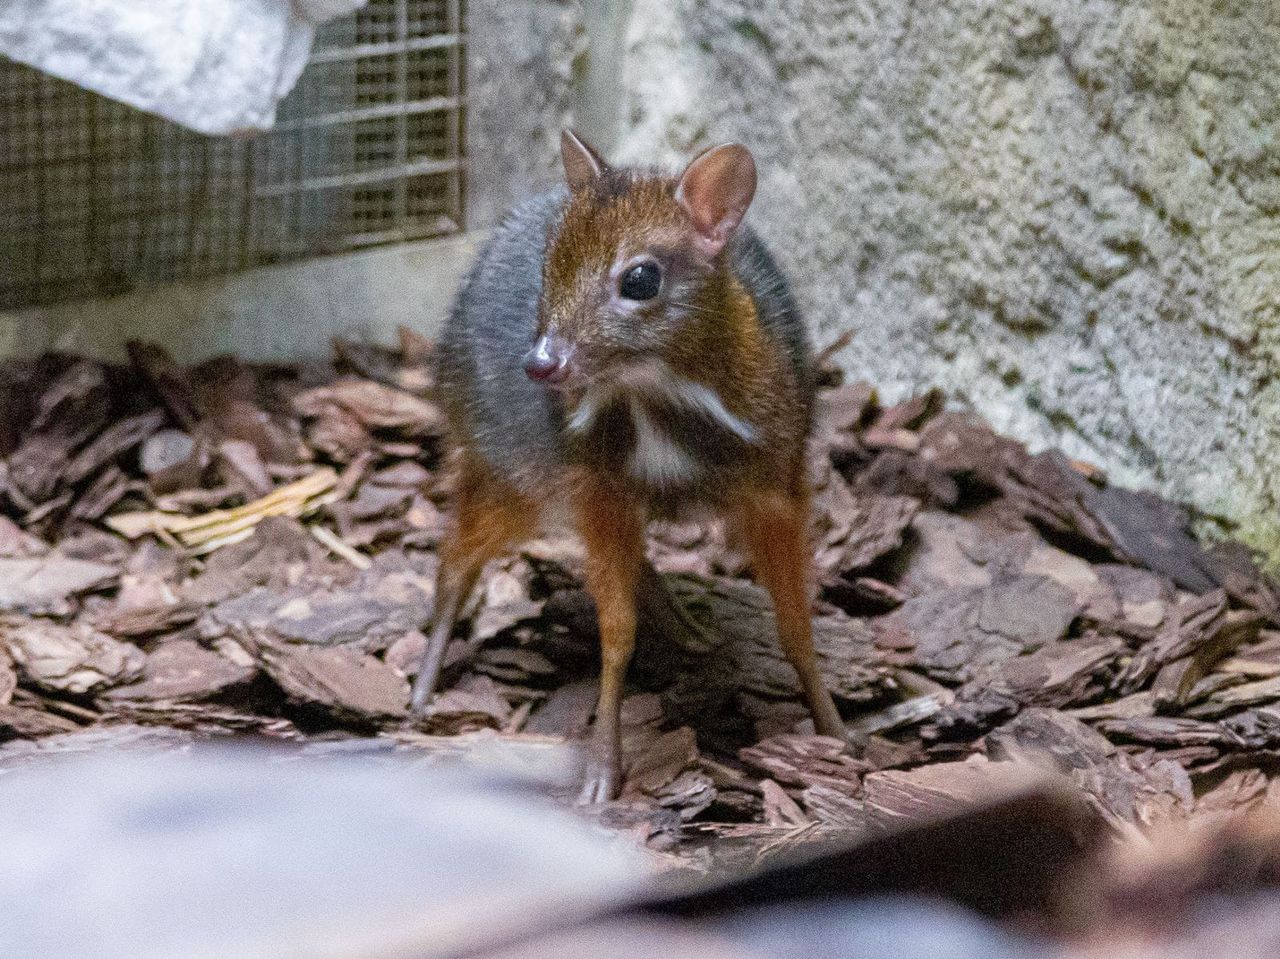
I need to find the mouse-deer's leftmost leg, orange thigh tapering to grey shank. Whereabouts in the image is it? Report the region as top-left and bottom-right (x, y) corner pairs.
(410, 460), (538, 713)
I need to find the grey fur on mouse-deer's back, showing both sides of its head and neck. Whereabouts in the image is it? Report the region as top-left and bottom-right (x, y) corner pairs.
(439, 186), (813, 489)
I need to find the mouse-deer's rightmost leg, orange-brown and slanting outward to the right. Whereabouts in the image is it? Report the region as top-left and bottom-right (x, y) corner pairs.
(737, 481), (849, 739)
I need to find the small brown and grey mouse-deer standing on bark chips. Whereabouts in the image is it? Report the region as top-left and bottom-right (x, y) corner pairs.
(413, 131), (845, 802)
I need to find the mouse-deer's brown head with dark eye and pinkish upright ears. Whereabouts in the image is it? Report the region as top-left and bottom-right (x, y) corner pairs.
(525, 131), (755, 385)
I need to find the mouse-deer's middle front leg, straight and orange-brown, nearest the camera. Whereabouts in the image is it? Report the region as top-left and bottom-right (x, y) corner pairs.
(576, 480), (644, 803)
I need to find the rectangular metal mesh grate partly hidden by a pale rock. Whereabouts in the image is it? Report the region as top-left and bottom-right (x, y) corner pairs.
(0, 0), (463, 307)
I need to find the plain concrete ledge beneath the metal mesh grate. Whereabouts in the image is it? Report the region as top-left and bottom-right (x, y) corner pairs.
(0, 233), (483, 362)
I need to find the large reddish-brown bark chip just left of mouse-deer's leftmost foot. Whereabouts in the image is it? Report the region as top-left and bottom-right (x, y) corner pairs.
(260, 643), (408, 721)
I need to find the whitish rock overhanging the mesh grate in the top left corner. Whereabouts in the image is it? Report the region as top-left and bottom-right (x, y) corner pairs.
(0, 0), (365, 134)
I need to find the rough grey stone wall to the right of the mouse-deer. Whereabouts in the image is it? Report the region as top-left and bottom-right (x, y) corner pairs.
(606, 0), (1280, 556)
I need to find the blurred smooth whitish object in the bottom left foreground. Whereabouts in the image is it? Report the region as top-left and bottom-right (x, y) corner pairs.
(0, 748), (643, 959)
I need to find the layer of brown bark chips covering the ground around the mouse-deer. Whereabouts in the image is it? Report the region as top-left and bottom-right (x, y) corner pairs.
(0, 333), (1280, 848)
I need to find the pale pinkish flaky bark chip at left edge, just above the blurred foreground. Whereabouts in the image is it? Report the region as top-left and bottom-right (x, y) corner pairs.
(0, 618), (146, 693)
